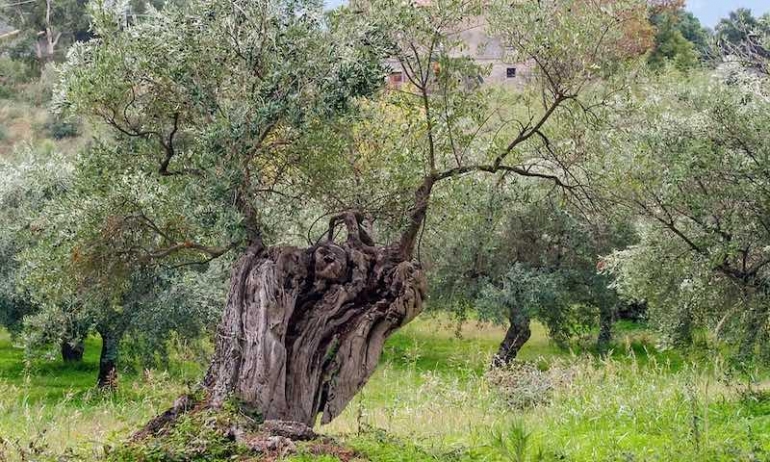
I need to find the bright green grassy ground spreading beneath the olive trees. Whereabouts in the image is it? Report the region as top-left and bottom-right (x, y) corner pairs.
(0, 318), (770, 461)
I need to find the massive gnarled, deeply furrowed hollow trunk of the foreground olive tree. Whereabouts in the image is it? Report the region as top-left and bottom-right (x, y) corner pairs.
(204, 213), (425, 427)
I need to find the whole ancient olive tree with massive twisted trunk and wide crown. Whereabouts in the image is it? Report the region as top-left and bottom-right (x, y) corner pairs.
(46, 0), (648, 428)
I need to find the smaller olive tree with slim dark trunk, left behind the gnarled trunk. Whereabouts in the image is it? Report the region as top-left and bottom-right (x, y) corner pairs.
(17, 144), (227, 388)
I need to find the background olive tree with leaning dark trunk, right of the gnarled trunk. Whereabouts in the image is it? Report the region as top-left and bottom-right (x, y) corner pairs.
(426, 183), (632, 364)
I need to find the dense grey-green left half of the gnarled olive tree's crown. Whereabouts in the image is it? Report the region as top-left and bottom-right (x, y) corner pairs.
(48, 2), (388, 293)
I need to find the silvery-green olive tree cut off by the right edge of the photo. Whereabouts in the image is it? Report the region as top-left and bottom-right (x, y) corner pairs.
(600, 66), (770, 357)
